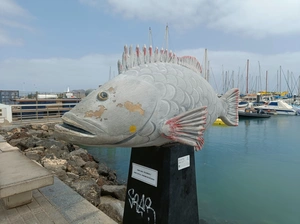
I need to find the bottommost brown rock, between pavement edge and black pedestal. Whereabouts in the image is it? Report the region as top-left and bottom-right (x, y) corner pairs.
(98, 196), (125, 223)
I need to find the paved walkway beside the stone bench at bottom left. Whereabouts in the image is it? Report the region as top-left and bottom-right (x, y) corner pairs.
(0, 177), (116, 224)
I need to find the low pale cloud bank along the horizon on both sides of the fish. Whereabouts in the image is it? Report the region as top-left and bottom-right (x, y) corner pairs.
(0, 49), (300, 93)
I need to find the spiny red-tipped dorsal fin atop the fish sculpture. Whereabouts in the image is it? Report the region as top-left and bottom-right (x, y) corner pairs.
(118, 45), (202, 74)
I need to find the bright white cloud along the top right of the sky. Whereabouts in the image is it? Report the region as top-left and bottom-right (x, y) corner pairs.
(80, 0), (300, 38)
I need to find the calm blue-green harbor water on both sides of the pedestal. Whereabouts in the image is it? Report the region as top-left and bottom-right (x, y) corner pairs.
(84, 115), (300, 224)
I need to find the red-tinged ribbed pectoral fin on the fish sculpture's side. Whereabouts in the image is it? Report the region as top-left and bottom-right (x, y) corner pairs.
(161, 107), (207, 151)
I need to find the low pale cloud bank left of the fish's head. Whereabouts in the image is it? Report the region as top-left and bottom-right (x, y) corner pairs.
(0, 54), (118, 91)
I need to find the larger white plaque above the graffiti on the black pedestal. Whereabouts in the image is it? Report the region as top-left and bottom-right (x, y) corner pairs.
(131, 163), (158, 187)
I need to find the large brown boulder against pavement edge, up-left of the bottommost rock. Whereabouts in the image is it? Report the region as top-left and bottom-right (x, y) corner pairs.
(71, 179), (101, 206)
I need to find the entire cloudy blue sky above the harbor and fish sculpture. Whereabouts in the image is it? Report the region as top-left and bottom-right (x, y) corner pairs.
(0, 0), (300, 94)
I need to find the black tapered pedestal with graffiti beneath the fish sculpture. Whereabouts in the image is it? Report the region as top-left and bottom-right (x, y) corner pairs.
(123, 144), (199, 224)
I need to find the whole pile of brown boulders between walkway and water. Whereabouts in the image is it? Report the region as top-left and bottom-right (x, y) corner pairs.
(0, 123), (126, 223)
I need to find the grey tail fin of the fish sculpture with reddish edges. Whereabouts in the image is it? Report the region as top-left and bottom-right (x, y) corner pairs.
(220, 88), (239, 126)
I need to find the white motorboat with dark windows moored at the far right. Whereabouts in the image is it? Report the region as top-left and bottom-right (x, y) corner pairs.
(254, 100), (297, 115)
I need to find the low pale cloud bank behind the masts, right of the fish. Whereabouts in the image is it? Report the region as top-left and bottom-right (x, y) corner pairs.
(178, 49), (300, 93)
